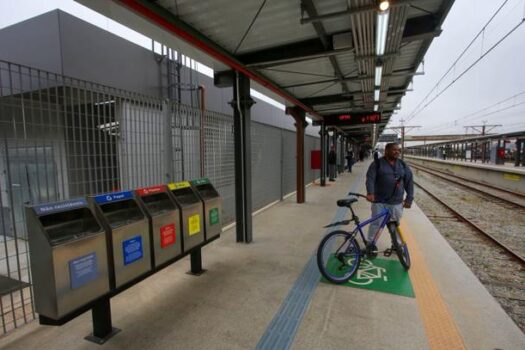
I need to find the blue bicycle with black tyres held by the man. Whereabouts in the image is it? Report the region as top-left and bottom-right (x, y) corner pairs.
(317, 192), (410, 284)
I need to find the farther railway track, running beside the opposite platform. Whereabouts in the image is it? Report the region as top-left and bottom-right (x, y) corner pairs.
(408, 162), (525, 209)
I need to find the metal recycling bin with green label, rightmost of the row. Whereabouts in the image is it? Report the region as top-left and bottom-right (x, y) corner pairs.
(191, 178), (222, 239)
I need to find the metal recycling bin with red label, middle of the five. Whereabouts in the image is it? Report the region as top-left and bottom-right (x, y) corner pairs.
(135, 185), (182, 267)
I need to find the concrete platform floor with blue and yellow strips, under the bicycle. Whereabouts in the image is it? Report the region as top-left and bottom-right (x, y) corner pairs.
(0, 163), (525, 350)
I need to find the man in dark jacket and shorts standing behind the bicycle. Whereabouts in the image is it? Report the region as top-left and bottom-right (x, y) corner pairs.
(366, 143), (414, 240)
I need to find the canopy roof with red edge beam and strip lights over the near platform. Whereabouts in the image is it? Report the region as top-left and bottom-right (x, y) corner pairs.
(76, 0), (454, 139)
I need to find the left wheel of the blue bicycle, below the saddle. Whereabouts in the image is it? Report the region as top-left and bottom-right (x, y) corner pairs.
(317, 231), (361, 284)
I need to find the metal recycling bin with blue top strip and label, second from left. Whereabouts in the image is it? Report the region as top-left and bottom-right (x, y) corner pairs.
(88, 191), (151, 288)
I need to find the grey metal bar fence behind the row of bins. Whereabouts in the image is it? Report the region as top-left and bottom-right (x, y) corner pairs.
(0, 61), (319, 333)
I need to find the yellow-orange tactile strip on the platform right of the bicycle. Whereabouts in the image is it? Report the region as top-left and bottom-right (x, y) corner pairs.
(401, 223), (465, 350)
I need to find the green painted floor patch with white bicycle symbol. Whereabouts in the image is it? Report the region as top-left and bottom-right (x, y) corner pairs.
(321, 256), (415, 298)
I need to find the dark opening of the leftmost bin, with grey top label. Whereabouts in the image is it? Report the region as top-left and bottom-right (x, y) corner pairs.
(39, 208), (102, 245)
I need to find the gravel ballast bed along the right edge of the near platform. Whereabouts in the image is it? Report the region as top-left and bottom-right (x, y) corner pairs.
(414, 170), (525, 333)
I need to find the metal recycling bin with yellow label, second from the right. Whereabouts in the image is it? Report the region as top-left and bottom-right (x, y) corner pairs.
(168, 181), (204, 252)
